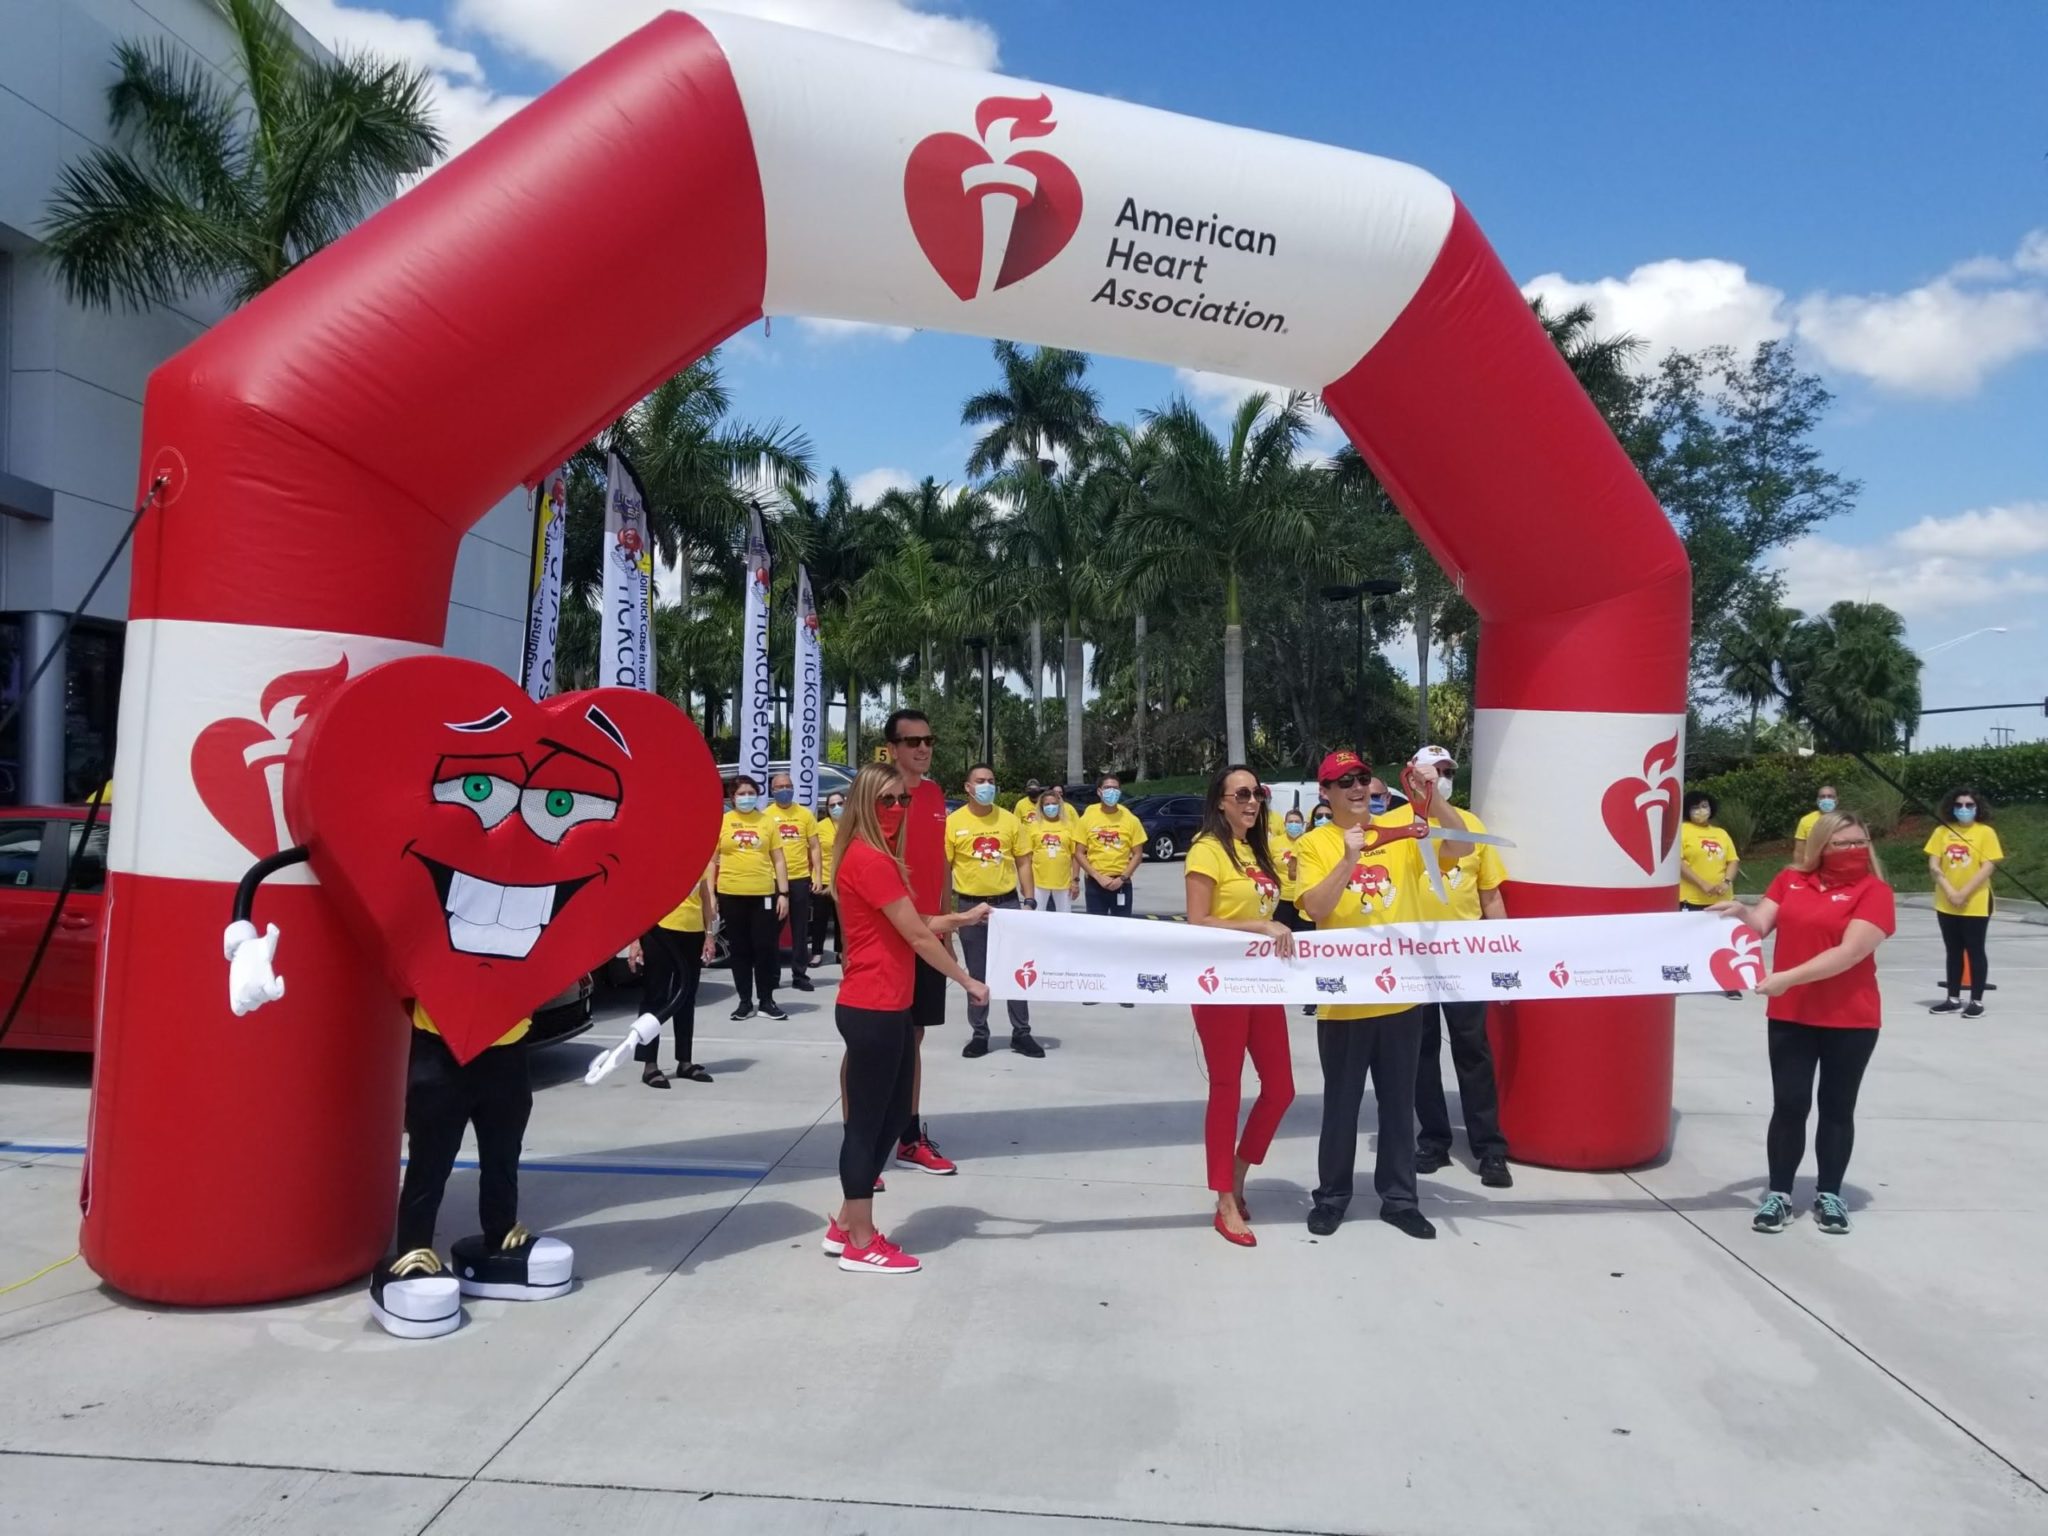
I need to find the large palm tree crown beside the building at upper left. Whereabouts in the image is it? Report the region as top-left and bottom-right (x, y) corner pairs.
(43, 0), (446, 309)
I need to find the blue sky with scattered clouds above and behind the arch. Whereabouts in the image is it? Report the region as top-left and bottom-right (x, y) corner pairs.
(285, 0), (2048, 741)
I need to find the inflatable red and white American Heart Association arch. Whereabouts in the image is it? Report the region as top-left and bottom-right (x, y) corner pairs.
(84, 14), (1690, 1303)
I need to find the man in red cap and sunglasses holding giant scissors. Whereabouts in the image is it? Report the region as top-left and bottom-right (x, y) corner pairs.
(1294, 752), (1473, 1237)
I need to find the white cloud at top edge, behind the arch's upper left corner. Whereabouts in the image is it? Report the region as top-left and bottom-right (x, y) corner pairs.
(451, 0), (997, 70)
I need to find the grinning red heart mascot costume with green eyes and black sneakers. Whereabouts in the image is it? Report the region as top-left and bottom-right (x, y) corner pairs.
(225, 655), (721, 1337)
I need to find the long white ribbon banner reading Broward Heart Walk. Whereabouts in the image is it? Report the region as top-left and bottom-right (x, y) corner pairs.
(987, 911), (1763, 1006)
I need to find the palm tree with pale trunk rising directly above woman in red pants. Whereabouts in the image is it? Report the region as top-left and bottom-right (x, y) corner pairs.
(1124, 393), (1325, 762)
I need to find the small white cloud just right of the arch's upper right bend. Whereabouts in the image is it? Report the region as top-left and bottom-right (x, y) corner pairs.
(1522, 258), (1790, 362)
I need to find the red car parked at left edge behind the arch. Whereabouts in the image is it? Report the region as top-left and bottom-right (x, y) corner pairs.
(0, 805), (594, 1051)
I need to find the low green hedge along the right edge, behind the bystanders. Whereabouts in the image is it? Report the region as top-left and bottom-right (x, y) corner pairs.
(1690, 741), (2048, 838)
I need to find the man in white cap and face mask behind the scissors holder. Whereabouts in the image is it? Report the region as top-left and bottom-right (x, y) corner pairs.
(1411, 748), (1516, 1190)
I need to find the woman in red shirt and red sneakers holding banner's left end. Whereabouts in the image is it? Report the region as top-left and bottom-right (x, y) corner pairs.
(825, 762), (989, 1274)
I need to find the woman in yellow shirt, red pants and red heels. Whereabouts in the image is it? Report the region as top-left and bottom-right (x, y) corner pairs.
(1188, 766), (1294, 1247)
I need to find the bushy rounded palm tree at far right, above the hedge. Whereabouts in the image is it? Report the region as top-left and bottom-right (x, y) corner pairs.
(1784, 602), (1921, 752)
